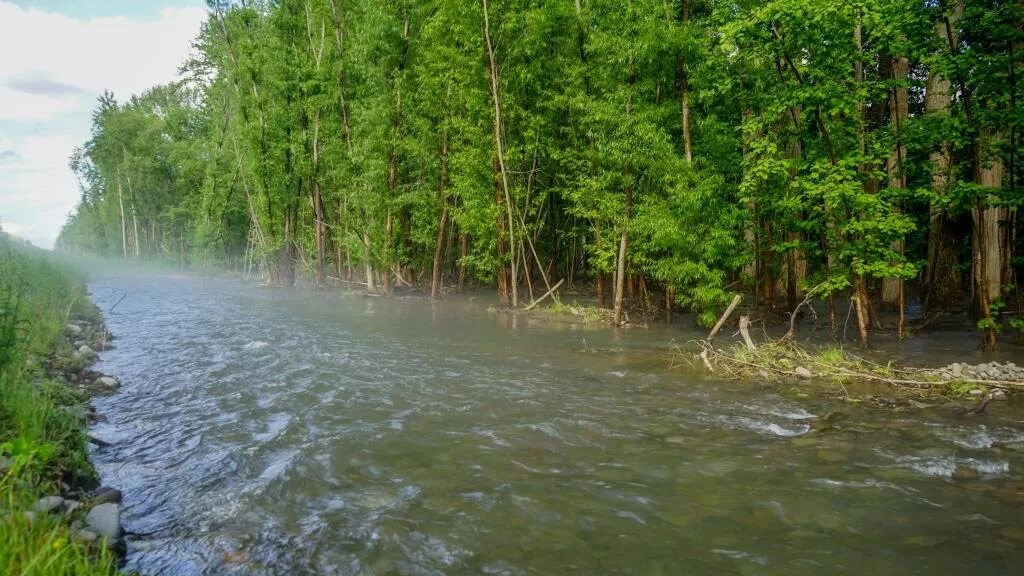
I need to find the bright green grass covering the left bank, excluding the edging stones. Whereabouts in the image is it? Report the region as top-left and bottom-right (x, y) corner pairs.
(0, 233), (115, 576)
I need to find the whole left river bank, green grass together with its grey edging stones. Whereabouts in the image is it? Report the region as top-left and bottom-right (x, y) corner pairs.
(0, 233), (123, 576)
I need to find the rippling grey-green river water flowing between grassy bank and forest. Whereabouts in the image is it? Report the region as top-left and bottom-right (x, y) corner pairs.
(90, 277), (1024, 576)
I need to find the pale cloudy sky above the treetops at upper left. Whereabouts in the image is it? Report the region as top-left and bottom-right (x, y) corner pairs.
(0, 0), (207, 248)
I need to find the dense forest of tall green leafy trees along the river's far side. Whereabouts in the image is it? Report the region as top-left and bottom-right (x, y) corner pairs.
(57, 0), (1024, 346)
